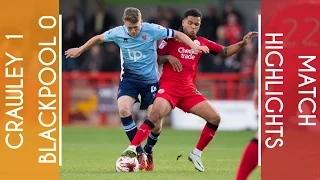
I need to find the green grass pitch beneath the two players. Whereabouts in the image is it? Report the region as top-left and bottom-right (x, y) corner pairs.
(60, 127), (260, 180)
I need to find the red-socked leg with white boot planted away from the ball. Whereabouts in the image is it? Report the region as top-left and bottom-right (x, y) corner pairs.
(181, 95), (220, 172)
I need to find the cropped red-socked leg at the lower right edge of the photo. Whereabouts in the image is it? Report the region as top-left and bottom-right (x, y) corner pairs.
(236, 133), (258, 180)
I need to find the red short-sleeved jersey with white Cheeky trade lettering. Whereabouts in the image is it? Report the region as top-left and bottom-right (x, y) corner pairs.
(158, 37), (223, 88)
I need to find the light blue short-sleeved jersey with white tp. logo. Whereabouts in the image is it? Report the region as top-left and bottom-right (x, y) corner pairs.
(104, 23), (174, 84)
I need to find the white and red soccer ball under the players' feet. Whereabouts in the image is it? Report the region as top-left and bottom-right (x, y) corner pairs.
(116, 156), (139, 172)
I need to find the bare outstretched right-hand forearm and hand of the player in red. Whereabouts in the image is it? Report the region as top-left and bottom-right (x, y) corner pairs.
(219, 32), (258, 56)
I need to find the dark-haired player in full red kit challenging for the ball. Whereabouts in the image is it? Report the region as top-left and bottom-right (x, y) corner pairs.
(122, 9), (257, 172)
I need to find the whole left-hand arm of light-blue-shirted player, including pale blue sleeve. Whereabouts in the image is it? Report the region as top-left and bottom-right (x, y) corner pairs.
(65, 28), (116, 58)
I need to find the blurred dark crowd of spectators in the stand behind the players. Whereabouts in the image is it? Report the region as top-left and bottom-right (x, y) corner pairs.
(62, 0), (260, 74)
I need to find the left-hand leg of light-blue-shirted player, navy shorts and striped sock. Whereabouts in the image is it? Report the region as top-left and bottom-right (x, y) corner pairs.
(117, 79), (143, 152)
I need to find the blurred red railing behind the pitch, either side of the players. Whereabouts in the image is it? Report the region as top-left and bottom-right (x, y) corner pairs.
(62, 72), (253, 126)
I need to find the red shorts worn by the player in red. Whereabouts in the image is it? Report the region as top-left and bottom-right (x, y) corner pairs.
(156, 83), (207, 112)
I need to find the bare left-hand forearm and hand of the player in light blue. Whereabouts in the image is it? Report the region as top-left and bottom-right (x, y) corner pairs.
(65, 34), (105, 58)
